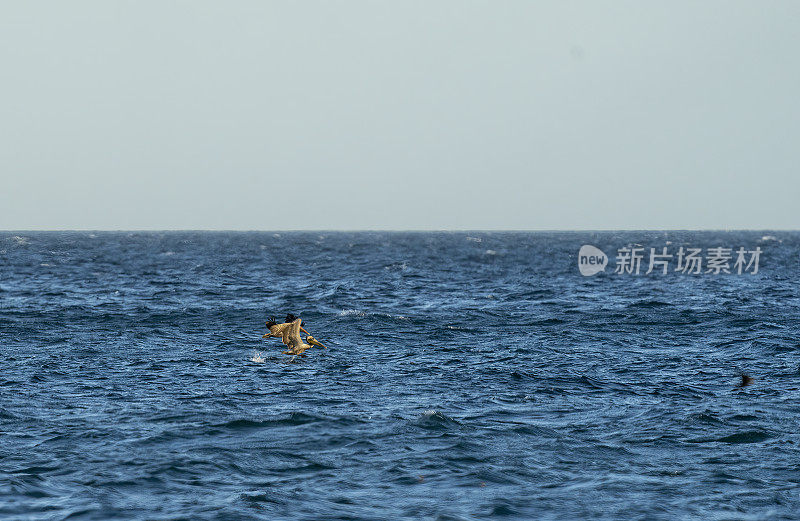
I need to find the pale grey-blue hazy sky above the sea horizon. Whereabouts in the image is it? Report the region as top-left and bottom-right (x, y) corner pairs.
(0, 0), (800, 230)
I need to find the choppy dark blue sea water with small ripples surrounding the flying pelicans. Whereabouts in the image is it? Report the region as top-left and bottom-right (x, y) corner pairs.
(0, 232), (800, 520)
